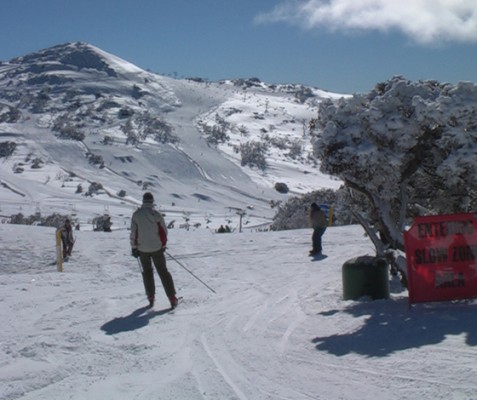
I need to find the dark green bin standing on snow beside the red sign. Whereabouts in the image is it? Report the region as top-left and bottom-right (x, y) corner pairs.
(342, 256), (389, 300)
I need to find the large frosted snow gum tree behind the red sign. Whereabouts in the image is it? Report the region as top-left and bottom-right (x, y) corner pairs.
(312, 77), (477, 272)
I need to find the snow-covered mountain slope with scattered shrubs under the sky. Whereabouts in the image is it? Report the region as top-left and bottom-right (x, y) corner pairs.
(0, 42), (340, 230)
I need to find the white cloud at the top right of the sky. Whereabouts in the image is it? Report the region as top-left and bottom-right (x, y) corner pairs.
(256, 0), (477, 44)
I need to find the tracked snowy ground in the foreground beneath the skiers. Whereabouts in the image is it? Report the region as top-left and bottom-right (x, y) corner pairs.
(0, 225), (477, 400)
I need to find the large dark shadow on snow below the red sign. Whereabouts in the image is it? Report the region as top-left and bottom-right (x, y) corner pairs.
(312, 299), (477, 357)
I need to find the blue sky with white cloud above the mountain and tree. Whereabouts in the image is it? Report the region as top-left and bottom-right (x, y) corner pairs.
(0, 0), (477, 93)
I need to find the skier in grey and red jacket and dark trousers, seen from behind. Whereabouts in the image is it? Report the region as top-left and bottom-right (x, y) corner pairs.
(130, 192), (178, 308)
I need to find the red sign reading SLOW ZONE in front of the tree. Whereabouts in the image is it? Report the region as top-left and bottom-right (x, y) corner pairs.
(404, 214), (477, 303)
